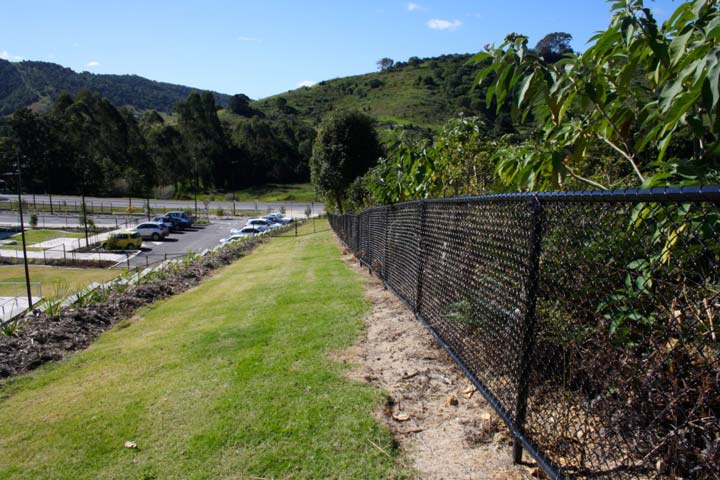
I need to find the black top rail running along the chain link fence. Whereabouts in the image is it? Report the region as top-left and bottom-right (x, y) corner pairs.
(340, 185), (720, 215)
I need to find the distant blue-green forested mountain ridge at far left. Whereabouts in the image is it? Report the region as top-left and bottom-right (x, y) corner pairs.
(0, 59), (230, 115)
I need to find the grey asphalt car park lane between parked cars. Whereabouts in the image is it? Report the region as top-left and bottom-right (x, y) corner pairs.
(118, 217), (249, 268)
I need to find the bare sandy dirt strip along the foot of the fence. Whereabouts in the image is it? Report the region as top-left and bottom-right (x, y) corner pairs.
(334, 249), (533, 480)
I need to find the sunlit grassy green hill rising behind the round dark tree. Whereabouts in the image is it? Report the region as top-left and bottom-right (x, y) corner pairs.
(251, 54), (496, 129)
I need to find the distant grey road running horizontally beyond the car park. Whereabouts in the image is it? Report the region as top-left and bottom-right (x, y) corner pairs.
(0, 194), (325, 217)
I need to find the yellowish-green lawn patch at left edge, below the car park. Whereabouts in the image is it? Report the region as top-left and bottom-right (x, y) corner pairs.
(0, 265), (122, 297)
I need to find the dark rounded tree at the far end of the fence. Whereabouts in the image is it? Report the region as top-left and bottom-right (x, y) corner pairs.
(310, 112), (382, 212)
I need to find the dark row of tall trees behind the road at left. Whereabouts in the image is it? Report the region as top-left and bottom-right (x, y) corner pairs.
(0, 90), (315, 197)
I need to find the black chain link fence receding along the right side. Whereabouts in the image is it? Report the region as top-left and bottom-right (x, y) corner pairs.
(330, 187), (720, 478)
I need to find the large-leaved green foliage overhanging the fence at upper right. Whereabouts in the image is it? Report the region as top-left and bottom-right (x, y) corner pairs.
(473, 0), (720, 188)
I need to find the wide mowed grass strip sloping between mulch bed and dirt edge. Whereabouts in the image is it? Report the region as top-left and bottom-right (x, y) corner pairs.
(0, 224), (409, 479)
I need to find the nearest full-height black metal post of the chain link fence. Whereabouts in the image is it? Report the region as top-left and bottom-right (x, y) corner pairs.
(513, 197), (543, 463)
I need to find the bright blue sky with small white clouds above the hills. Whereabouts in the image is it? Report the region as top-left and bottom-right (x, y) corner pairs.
(0, 0), (678, 98)
